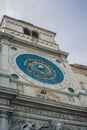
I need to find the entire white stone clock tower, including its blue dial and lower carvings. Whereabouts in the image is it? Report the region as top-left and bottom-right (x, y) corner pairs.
(0, 16), (87, 130)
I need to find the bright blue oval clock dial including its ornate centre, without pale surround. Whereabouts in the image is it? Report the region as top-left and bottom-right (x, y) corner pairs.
(16, 54), (64, 84)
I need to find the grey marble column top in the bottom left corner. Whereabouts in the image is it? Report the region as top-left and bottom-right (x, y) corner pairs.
(0, 111), (8, 130)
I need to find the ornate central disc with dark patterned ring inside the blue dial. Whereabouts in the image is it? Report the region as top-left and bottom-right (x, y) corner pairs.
(24, 58), (56, 78)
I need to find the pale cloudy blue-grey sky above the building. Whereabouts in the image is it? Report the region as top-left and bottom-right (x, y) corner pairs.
(0, 0), (87, 65)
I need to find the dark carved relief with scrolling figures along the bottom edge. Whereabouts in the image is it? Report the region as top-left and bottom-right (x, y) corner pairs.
(9, 117), (87, 130)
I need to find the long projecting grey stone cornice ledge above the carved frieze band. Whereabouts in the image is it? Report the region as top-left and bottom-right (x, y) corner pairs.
(13, 95), (87, 114)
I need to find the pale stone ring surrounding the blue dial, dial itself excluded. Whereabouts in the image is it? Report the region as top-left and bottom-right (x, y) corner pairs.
(9, 50), (70, 90)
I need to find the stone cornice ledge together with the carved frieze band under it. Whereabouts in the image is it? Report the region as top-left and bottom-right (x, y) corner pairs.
(11, 95), (87, 123)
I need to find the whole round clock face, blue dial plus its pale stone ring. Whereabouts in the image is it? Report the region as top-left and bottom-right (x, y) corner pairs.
(9, 47), (68, 89)
